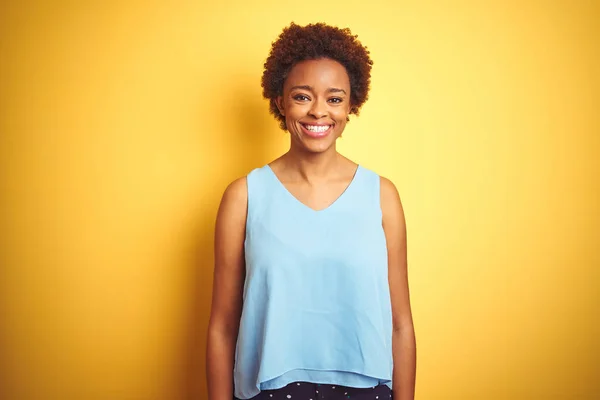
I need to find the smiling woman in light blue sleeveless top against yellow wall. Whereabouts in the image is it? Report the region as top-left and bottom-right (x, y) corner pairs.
(207, 23), (416, 400)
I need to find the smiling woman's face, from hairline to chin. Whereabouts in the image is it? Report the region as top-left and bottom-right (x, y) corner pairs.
(277, 58), (350, 153)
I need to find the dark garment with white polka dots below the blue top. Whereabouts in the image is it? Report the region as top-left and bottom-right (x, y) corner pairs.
(236, 382), (392, 400)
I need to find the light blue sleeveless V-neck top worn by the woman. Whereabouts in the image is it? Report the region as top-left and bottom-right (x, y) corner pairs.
(234, 165), (393, 399)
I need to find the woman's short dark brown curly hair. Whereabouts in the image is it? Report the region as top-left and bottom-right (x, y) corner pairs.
(261, 22), (373, 130)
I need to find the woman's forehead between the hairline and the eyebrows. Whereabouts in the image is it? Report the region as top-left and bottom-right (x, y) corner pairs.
(284, 58), (350, 90)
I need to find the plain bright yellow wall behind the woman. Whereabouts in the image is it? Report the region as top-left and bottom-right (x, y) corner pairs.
(0, 0), (600, 400)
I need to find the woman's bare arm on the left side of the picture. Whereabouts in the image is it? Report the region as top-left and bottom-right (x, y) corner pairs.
(206, 178), (248, 400)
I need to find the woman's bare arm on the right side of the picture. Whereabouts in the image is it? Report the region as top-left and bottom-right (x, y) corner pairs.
(381, 178), (416, 400)
